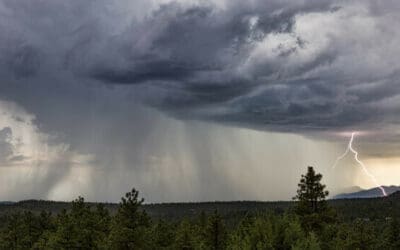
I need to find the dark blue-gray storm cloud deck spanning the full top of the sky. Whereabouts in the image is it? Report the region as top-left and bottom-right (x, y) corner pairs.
(0, 0), (400, 141)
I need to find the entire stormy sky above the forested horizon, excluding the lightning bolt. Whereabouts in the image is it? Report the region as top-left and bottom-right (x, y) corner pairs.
(0, 0), (400, 202)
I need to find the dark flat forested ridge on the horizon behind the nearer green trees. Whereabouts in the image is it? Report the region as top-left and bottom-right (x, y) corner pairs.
(0, 192), (400, 220)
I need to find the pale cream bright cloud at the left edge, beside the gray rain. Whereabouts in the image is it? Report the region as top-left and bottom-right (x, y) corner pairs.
(0, 101), (95, 200)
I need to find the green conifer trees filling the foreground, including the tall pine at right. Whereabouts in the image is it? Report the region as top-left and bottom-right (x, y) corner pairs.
(0, 167), (400, 250)
